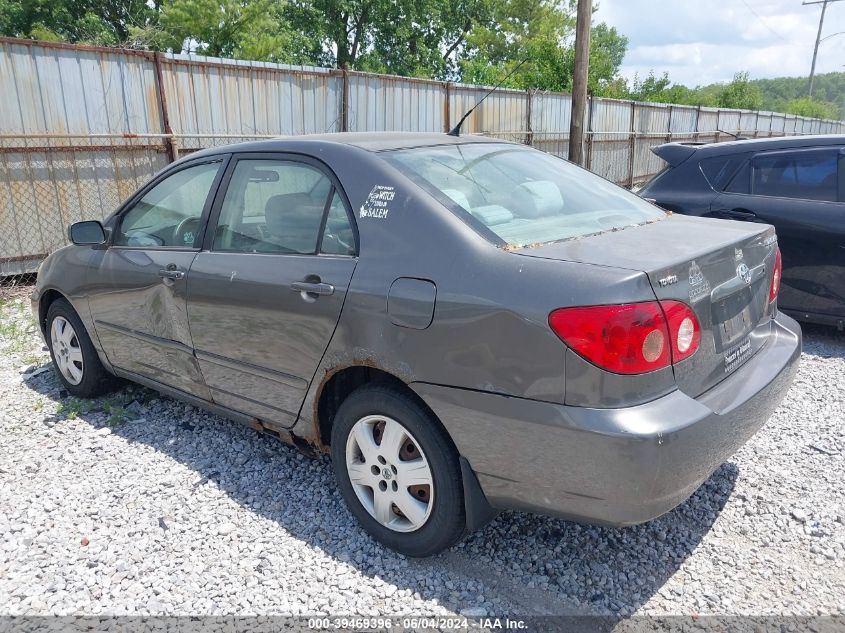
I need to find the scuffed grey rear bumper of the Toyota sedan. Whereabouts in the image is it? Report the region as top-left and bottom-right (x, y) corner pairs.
(411, 314), (801, 526)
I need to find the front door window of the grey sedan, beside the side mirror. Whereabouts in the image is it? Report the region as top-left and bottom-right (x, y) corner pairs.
(114, 162), (222, 248)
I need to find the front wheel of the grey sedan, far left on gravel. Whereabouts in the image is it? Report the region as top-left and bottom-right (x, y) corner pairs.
(45, 299), (118, 398)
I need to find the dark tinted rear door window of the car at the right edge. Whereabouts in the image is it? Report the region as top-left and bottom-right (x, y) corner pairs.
(752, 150), (838, 202)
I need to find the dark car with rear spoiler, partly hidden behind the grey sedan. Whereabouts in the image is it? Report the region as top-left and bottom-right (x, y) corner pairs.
(639, 135), (845, 330)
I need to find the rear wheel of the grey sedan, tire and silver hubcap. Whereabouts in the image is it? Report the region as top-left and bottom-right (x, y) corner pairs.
(331, 385), (466, 556)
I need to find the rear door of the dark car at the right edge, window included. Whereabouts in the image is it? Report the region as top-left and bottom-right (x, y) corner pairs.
(711, 147), (845, 315)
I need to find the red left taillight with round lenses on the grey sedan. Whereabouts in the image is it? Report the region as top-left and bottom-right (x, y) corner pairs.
(549, 301), (701, 374)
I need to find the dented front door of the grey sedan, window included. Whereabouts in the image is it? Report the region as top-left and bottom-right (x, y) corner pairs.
(89, 157), (224, 399)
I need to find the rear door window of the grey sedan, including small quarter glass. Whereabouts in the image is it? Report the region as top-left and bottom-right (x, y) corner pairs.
(214, 159), (354, 255)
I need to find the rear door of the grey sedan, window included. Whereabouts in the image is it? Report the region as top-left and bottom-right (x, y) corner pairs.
(188, 154), (357, 427)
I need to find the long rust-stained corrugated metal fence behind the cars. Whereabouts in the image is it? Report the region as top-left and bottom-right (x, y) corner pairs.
(0, 38), (845, 275)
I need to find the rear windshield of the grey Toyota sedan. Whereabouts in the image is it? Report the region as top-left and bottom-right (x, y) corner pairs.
(384, 143), (665, 247)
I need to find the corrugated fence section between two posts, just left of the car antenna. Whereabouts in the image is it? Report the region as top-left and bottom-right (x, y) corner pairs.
(348, 72), (446, 132)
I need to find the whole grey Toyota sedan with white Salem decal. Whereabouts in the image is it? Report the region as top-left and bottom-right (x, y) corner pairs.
(32, 133), (801, 556)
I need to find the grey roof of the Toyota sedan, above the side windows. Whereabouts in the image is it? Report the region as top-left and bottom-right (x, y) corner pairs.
(183, 132), (509, 157)
